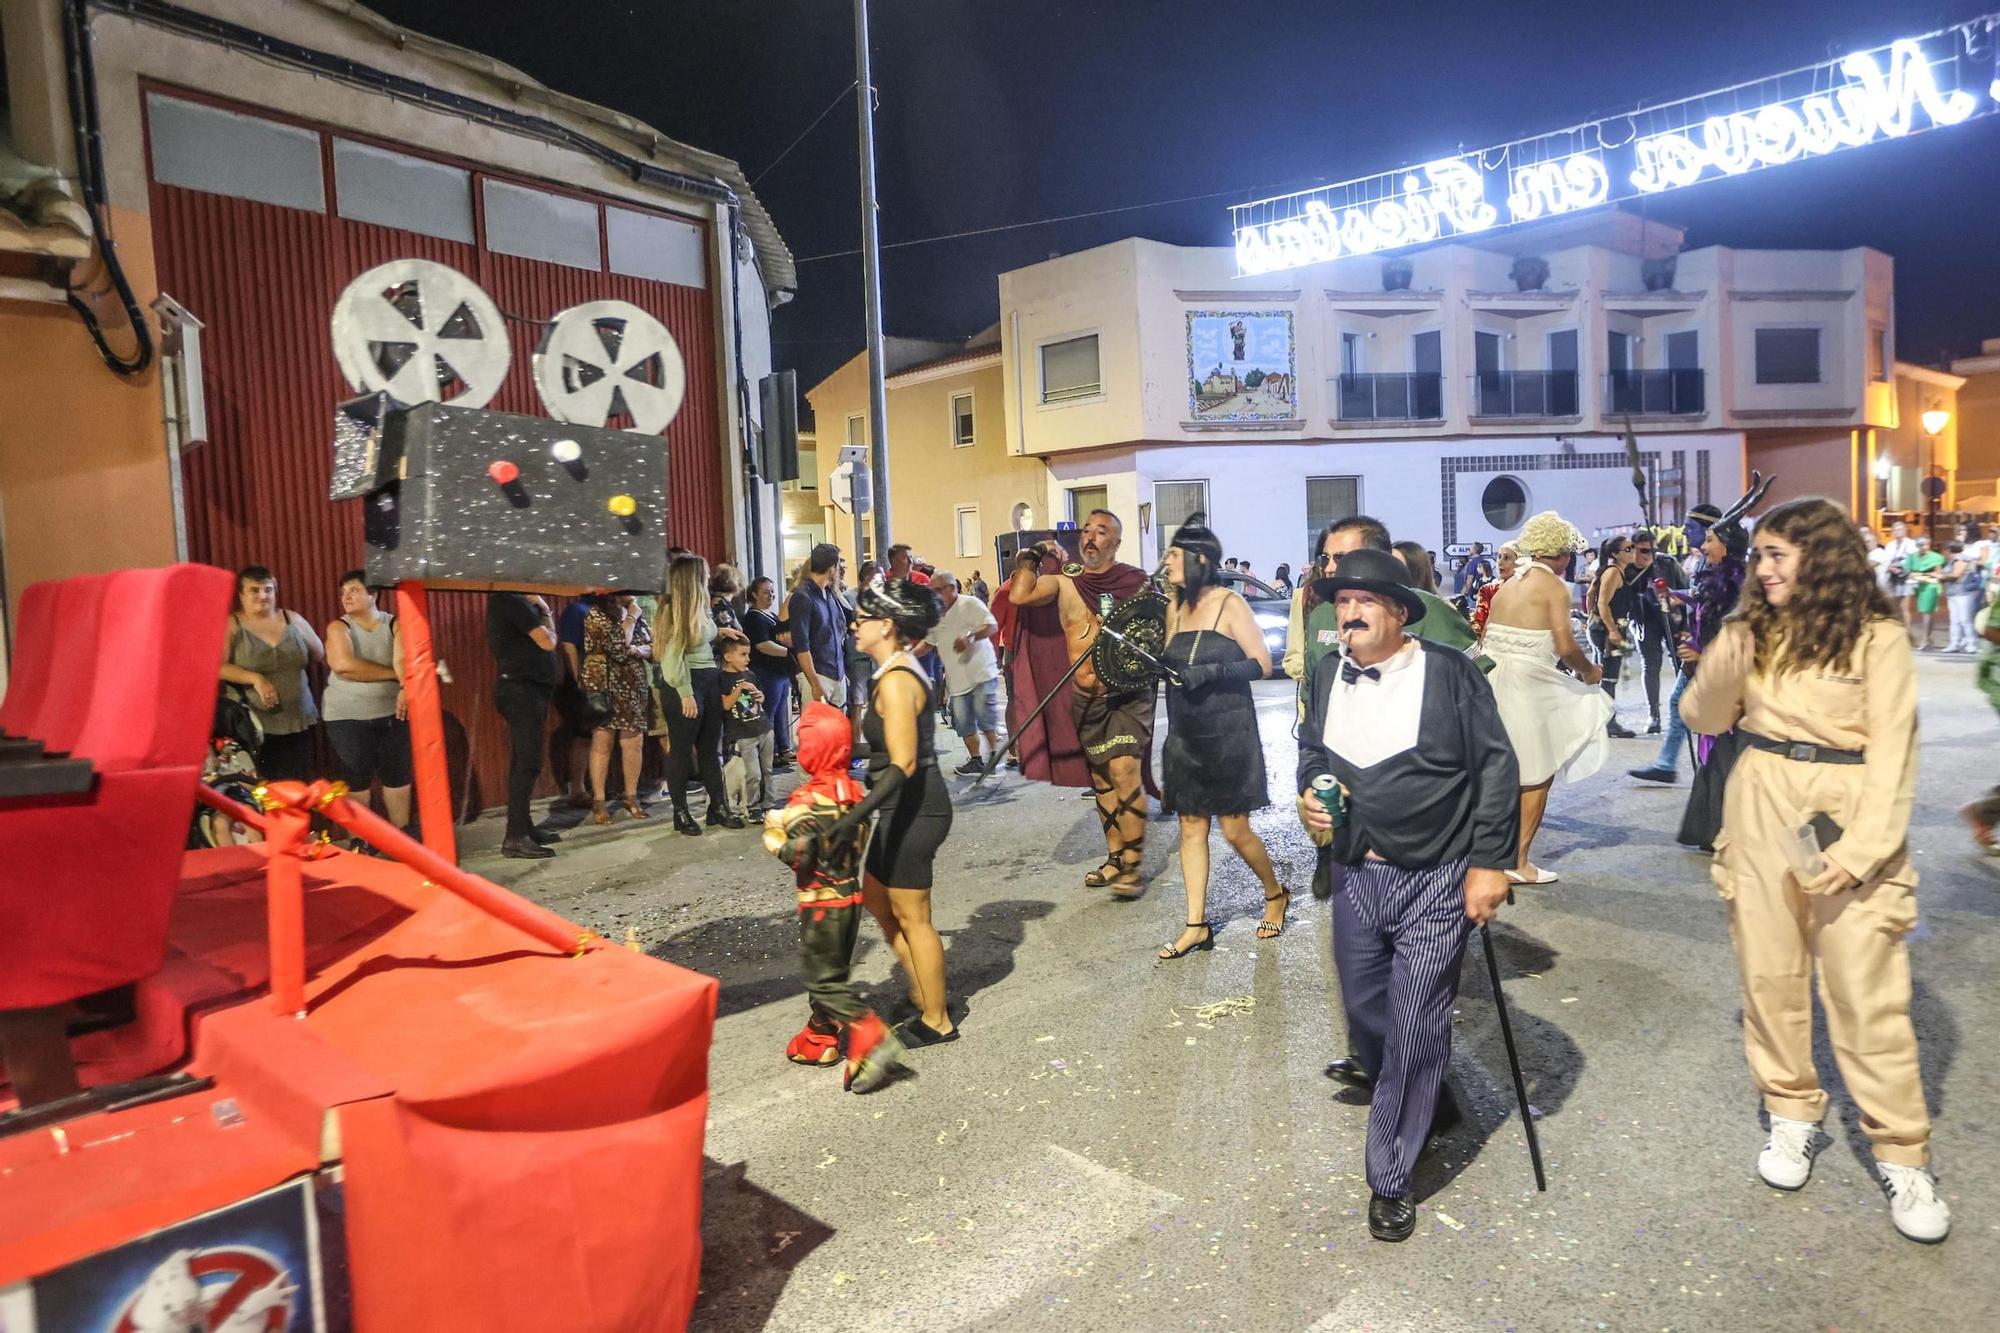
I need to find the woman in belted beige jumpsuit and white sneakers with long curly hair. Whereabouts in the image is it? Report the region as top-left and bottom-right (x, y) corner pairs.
(1680, 500), (1950, 1241)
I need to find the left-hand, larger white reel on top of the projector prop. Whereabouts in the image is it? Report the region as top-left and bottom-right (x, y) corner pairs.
(334, 260), (510, 406)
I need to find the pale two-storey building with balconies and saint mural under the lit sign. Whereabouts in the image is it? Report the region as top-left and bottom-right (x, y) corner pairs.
(1000, 214), (1896, 572)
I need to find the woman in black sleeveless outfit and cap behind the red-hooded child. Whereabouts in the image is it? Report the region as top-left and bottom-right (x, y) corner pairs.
(842, 578), (958, 1047)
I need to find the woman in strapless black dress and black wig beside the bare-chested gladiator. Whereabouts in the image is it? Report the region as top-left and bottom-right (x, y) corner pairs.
(1160, 518), (1292, 959)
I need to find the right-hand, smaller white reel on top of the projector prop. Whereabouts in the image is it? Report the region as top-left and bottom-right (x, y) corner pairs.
(534, 300), (688, 434)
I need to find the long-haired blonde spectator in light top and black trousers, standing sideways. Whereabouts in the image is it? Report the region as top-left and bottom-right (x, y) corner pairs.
(652, 554), (744, 837)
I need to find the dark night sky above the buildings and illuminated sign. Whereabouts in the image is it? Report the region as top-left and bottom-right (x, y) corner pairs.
(374, 0), (2000, 386)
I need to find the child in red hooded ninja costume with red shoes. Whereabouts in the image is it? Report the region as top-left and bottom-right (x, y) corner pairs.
(764, 703), (902, 1093)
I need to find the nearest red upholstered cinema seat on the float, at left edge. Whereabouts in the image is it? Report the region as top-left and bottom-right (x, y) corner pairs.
(0, 564), (232, 1009)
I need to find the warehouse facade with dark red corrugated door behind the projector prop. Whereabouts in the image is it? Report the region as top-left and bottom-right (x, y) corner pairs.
(0, 0), (796, 792)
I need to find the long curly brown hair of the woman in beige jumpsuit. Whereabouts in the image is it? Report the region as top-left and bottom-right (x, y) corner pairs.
(1730, 496), (1898, 675)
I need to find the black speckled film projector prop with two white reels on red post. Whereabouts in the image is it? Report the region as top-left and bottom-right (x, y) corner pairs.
(328, 260), (688, 861)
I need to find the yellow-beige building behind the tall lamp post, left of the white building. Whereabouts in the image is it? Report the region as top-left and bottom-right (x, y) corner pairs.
(786, 326), (1066, 582)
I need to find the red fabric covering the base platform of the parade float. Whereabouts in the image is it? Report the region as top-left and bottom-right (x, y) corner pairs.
(0, 847), (716, 1333)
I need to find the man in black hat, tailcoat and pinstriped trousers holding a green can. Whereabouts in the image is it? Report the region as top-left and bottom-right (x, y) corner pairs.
(1298, 550), (1520, 1241)
